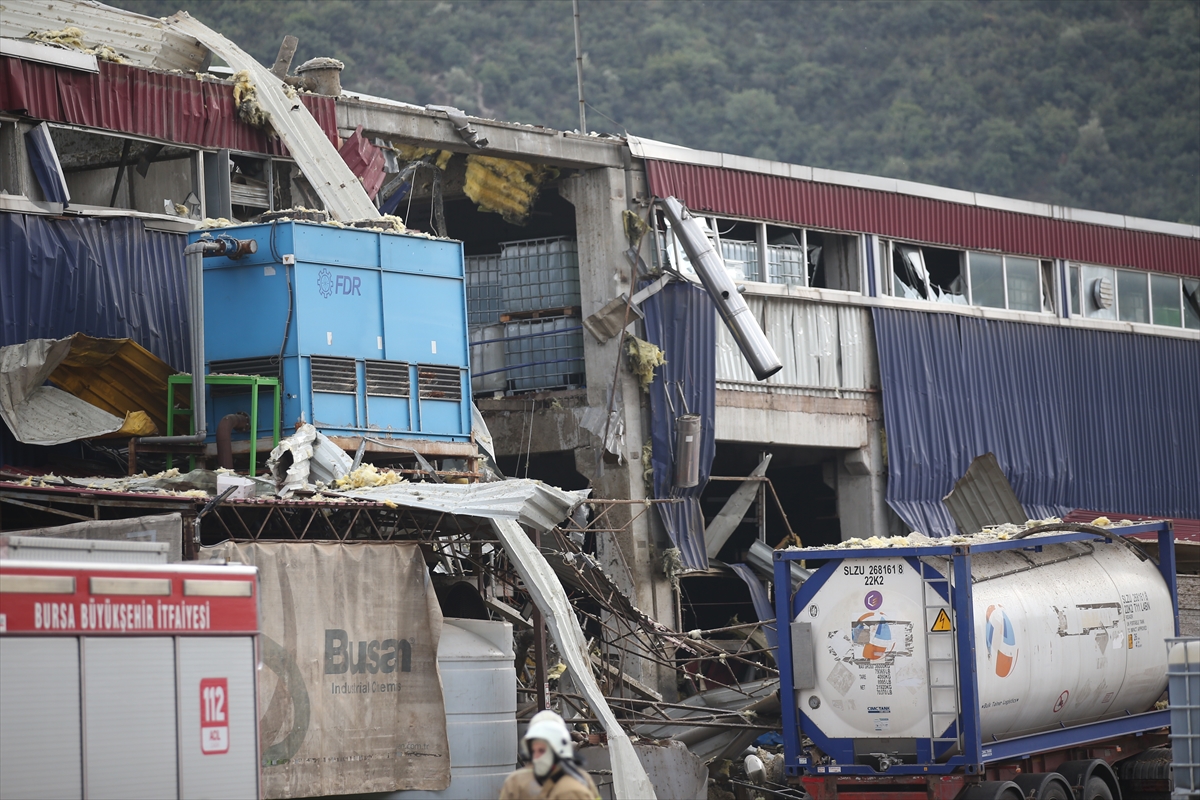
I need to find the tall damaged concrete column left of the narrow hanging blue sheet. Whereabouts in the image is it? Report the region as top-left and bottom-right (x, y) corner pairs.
(559, 168), (676, 691)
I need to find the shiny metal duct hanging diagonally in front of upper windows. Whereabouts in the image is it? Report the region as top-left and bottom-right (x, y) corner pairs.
(662, 197), (784, 380)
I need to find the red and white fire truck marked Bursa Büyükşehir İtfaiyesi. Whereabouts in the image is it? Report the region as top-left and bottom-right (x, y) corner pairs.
(0, 556), (260, 800)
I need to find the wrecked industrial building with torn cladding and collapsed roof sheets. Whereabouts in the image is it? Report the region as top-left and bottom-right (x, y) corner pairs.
(0, 0), (1200, 798)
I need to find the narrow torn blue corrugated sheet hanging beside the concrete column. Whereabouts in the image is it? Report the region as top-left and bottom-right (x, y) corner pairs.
(642, 283), (716, 570)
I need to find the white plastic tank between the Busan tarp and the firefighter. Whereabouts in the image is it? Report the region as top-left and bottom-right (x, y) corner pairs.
(393, 618), (517, 800)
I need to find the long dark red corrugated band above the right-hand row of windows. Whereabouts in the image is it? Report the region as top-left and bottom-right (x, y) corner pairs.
(646, 160), (1200, 277)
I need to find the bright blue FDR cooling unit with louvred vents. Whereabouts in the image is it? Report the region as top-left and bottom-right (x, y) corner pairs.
(188, 222), (470, 441)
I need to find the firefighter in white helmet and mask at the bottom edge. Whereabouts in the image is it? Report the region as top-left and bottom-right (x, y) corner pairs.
(500, 711), (600, 800)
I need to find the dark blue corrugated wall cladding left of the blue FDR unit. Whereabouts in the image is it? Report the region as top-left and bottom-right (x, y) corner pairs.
(0, 213), (191, 372)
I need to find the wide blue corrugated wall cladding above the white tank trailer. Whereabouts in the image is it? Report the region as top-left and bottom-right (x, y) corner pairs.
(872, 308), (1200, 536)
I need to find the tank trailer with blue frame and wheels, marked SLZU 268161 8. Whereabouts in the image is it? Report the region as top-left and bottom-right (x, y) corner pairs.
(774, 522), (1178, 800)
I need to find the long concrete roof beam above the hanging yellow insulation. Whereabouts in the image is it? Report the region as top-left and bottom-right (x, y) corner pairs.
(337, 98), (629, 170)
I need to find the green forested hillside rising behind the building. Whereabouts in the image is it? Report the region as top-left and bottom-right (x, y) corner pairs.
(110, 0), (1200, 223)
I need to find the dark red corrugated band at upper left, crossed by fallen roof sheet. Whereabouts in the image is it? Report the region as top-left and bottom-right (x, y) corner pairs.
(0, 56), (338, 156)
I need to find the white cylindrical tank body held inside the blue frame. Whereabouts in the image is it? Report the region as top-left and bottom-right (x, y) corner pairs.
(796, 540), (1174, 740)
